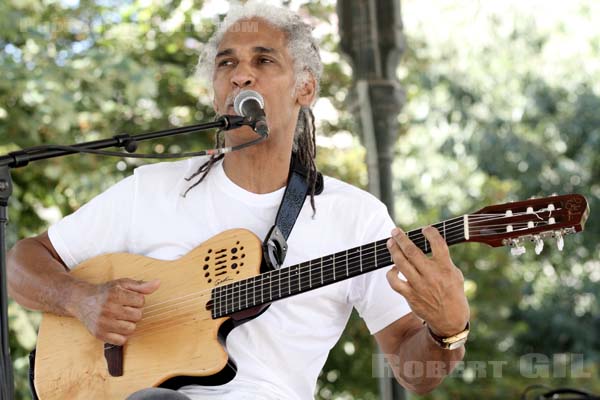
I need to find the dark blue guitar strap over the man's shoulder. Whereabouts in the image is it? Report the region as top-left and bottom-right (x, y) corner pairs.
(263, 152), (324, 269)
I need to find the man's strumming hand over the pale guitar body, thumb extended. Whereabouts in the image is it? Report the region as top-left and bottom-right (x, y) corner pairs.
(72, 278), (160, 346)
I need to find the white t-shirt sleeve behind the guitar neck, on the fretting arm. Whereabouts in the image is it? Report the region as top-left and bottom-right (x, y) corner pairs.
(350, 204), (411, 334)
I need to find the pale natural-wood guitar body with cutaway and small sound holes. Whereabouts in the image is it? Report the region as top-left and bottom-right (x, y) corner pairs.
(34, 229), (266, 400)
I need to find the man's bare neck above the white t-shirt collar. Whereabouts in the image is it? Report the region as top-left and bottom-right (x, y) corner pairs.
(223, 133), (292, 194)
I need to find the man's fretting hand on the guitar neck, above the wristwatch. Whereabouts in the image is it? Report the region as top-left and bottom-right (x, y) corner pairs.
(387, 226), (470, 337)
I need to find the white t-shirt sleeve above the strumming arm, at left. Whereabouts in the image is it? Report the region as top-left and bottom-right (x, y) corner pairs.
(48, 175), (135, 268)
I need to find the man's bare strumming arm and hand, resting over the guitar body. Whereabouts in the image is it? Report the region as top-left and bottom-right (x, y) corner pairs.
(7, 232), (160, 345)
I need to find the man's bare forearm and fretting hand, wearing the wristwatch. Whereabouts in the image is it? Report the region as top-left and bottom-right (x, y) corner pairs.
(376, 227), (470, 393)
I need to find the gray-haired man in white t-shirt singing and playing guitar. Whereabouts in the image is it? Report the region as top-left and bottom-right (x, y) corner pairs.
(8, 2), (469, 400)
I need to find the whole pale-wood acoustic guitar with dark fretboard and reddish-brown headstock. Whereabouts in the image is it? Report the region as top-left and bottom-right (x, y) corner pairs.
(34, 194), (589, 400)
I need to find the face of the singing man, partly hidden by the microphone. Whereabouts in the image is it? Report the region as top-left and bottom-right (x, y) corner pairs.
(213, 19), (299, 141)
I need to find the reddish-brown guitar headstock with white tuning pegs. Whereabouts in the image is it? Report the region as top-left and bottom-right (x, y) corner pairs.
(467, 194), (590, 255)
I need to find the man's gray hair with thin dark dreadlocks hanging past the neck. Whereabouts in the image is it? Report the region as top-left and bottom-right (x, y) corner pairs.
(184, 1), (323, 212)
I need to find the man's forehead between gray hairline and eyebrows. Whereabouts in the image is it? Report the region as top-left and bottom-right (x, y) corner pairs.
(217, 18), (287, 53)
